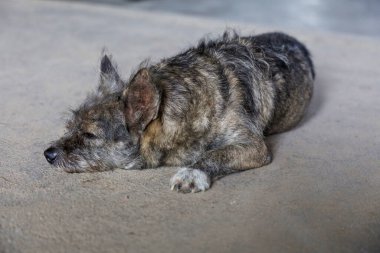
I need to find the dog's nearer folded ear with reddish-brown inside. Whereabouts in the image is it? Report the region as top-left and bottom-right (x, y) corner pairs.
(123, 68), (161, 144)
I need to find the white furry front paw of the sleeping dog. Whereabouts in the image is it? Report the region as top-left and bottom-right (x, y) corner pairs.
(170, 168), (210, 193)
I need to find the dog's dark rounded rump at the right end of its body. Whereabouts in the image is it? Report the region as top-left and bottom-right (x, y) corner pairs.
(248, 33), (315, 134)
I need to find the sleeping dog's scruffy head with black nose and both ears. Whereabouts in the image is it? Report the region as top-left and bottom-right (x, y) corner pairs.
(44, 55), (158, 172)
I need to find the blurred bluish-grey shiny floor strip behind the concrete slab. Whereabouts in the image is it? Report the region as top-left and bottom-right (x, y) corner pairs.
(67, 0), (380, 37)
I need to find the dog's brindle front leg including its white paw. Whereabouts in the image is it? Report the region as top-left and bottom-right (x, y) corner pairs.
(170, 138), (271, 193)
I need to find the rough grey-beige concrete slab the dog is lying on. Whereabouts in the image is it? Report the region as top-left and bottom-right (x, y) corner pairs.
(0, 1), (380, 253)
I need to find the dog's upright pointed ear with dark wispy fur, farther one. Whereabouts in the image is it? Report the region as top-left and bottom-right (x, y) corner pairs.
(98, 54), (123, 94)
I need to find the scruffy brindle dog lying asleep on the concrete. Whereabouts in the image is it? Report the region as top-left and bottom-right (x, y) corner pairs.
(44, 31), (315, 193)
